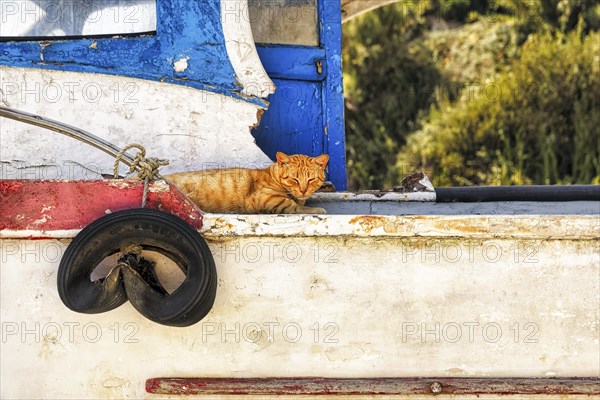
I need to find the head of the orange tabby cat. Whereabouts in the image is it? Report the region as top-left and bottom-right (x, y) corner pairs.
(276, 152), (329, 200)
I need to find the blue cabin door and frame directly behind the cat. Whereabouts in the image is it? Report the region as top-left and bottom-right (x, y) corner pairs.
(253, 0), (347, 190)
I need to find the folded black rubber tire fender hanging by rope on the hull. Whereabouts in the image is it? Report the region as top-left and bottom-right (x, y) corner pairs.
(57, 208), (217, 326)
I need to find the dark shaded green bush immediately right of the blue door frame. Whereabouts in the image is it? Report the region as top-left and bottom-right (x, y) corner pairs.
(343, 2), (441, 190)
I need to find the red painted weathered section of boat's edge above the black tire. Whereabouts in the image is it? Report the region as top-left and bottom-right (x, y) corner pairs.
(0, 180), (202, 231)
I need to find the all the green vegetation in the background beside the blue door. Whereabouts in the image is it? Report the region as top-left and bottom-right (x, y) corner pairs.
(344, 0), (600, 189)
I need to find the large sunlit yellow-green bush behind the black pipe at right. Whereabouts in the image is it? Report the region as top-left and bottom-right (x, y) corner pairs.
(397, 31), (600, 186)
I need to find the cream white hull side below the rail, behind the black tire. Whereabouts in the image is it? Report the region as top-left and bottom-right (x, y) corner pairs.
(0, 215), (600, 398)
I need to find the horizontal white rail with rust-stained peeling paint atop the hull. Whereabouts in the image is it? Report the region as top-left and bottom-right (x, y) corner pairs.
(0, 210), (600, 241)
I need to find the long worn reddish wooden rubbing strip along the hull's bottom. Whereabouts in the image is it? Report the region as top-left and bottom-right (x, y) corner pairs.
(146, 378), (600, 396)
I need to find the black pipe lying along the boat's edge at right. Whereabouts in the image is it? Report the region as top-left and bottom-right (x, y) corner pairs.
(435, 185), (600, 203)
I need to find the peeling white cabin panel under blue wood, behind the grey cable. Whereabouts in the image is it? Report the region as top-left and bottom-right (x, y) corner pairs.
(0, 66), (271, 179)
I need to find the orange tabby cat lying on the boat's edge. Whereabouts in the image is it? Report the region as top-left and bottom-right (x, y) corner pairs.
(165, 152), (329, 214)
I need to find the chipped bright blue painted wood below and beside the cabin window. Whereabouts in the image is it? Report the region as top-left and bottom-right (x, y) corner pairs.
(0, 0), (266, 105)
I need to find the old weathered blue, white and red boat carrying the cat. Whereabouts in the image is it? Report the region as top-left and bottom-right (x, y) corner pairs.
(0, 0), (600, 399)
